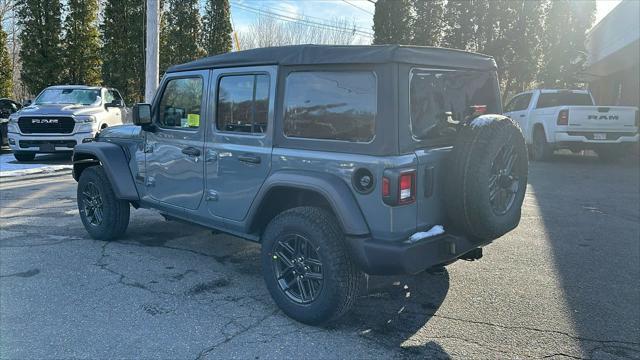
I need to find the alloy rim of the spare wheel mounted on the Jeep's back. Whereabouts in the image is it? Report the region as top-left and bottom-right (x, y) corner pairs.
(489, 144), (520, 215)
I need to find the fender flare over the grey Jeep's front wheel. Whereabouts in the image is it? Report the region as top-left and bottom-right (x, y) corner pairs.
(73, 141), (140, 201)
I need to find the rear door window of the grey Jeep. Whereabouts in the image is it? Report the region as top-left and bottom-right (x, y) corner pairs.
(216, 74), (269, 134)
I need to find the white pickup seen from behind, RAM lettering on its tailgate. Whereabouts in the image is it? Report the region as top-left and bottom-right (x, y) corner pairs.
(504, 89), (638, 161)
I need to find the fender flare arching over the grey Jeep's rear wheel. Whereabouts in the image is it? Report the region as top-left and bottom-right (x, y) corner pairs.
(247, 170), (369, 236)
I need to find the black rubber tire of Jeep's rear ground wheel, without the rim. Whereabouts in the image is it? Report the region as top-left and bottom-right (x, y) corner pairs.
(261, 207), (363, 325)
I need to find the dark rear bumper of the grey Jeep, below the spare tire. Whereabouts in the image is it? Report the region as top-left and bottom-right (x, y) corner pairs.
(347, 233), (491, 275)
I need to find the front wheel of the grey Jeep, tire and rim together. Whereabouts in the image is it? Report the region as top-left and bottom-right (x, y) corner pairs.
(77, 165), (129, 240)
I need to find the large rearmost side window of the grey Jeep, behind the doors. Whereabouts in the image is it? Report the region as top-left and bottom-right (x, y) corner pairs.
(284, 71), (377, 142)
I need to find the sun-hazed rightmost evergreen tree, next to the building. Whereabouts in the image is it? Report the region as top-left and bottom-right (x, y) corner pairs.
(538, 0), (595, 88)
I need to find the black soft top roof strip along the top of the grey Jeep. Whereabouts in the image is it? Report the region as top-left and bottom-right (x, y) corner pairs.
(167, 45), (496, 72)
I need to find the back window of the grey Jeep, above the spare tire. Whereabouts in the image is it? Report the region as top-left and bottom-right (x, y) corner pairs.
(409, 68), (501, 140)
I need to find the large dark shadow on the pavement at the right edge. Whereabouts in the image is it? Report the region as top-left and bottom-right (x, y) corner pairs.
(525, 155), (640, 358)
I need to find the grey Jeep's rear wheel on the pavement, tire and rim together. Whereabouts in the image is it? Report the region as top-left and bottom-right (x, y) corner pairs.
(262, 207), (362, 325)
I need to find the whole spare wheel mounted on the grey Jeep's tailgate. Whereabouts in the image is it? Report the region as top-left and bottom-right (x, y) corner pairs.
(446, 115), (528, 240)
